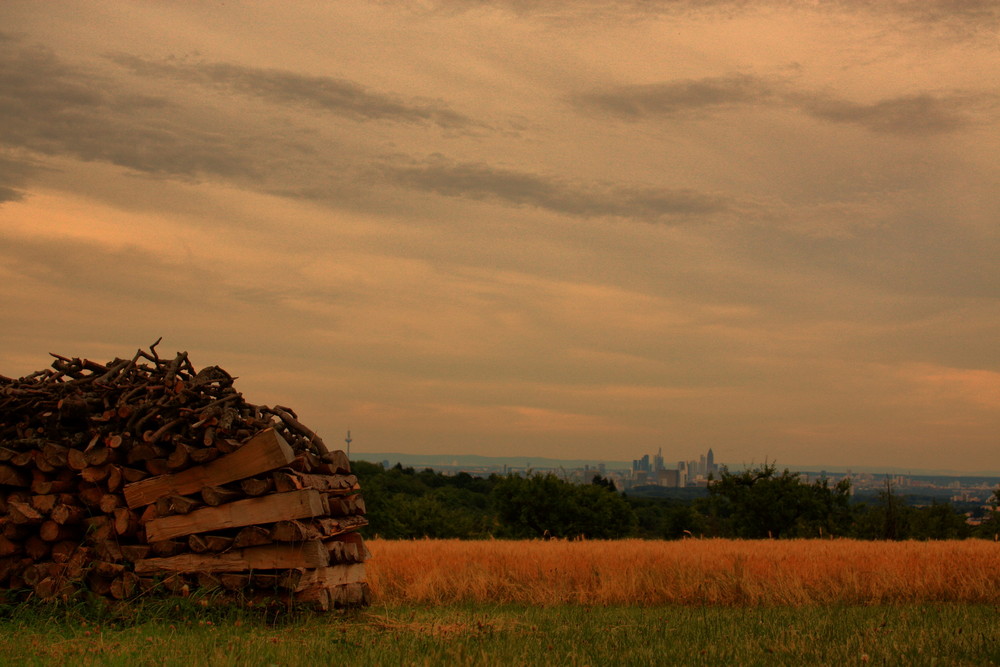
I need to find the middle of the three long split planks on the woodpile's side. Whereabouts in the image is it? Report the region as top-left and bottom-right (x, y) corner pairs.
(146, 488), (329, 542)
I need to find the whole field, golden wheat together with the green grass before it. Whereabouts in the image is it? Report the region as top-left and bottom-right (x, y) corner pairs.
(0, 540), (1000, 666)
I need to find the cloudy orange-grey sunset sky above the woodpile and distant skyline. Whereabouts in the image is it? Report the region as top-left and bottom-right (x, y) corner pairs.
(0, 0), (1000, 472)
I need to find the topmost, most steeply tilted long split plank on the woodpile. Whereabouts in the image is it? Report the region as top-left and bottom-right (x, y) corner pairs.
(125, 428), (295, 509)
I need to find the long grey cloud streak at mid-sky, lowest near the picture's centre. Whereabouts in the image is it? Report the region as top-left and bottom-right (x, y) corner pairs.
(379, 155), (729, 221)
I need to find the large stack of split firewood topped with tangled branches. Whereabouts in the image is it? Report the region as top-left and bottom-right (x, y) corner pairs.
(0, 341), (368, 609)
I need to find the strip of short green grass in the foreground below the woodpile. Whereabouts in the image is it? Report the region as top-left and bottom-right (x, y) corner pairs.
(0, 601), (1000, 667)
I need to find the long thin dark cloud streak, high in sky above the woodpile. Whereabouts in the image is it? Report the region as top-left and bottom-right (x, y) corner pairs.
(111, 55), (478, 129)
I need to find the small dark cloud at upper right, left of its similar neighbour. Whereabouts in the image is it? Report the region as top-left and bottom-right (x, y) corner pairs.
(571, 74), (772, 120)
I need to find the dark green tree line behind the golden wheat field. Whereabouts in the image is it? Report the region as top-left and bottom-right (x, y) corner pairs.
(351, 461), (1000, 540)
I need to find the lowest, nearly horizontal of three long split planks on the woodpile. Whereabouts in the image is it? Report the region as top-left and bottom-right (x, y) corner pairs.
(135, 542), (330, 574)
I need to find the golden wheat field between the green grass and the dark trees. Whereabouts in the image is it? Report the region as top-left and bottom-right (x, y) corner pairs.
(368, 539), (1000, 606)
